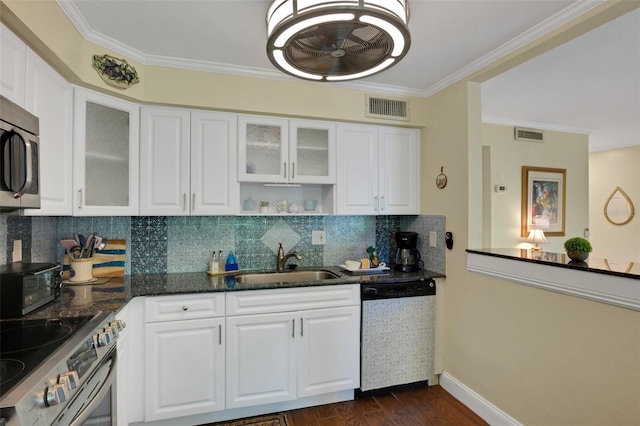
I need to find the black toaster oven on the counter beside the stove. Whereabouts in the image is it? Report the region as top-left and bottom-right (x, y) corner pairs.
(0, 262), (62, 318)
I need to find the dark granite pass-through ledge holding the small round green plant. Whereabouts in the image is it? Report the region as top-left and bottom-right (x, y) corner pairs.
(467, 248), (640, 280)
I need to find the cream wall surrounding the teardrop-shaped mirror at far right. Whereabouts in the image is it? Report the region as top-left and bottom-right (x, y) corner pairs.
(589, 145), (640, 262)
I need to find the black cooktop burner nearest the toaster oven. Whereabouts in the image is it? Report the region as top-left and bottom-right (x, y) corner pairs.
(0, 321), (73, 356)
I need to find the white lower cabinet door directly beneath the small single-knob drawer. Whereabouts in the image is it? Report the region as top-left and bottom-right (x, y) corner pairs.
(145, 318), (225, 421)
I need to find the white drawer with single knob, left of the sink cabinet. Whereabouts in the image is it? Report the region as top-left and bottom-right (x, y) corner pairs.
(144, 293), (224, 322)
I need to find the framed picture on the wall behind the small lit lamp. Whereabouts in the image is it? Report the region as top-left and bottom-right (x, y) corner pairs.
(521, 166), (567, 237)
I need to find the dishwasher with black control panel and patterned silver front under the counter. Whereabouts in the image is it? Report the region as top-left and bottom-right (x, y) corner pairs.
(357, 277), (436, 396)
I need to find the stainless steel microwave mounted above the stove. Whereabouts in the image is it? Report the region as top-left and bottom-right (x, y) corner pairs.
(0, 96), (40, 211)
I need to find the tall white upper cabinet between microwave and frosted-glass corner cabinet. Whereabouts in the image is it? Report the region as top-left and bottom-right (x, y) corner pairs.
(24, 49), (73, 216)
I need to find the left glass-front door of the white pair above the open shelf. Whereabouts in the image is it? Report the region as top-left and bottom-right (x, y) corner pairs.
(238, 115), (289, 183)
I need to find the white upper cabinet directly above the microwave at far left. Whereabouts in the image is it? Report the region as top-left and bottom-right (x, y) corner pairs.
(0, 24), (27, 108)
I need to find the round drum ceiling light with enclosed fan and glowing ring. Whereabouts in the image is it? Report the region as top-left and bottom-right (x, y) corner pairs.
(266, 0), (411, 81)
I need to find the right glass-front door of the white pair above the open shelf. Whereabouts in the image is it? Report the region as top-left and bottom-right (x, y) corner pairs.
(289, 120), (336, 184)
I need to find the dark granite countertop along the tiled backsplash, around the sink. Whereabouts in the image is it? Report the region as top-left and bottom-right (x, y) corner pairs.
(17, 267), (444, 319)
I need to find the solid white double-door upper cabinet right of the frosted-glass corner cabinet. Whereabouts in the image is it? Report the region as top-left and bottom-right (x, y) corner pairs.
(140, 107), (239, 216)
